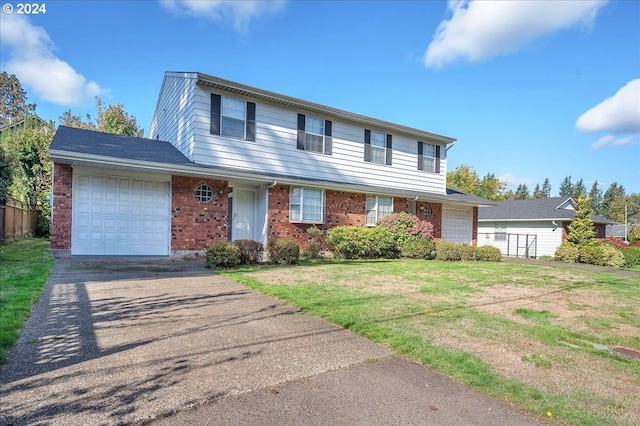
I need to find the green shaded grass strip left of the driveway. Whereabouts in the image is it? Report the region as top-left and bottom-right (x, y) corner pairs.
(0, 238), (53, 364)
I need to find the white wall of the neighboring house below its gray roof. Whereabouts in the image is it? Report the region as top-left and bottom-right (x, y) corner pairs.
(478, 220), (562, 257)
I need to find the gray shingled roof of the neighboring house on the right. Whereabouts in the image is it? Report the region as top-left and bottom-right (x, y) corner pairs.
(478, 197), (615, 224)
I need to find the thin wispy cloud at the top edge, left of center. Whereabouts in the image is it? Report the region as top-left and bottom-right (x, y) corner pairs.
(160, 0), (286, 33)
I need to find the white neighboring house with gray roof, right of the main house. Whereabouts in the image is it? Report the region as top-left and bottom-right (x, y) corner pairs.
(478, 197), (615, 257)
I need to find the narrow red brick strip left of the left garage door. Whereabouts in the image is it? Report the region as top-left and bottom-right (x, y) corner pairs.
(51, 164), (73, 250)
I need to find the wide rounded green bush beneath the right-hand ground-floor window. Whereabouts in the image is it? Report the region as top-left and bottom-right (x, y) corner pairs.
(327, 226), (400, 259)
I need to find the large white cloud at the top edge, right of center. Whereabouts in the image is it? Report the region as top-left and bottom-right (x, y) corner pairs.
(424, 0), (607, 68)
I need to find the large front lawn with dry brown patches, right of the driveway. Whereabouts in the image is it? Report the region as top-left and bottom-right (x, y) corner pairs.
(225, 260), (640, 425)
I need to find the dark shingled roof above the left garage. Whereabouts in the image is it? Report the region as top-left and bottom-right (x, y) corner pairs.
(49, 126), (193, 165)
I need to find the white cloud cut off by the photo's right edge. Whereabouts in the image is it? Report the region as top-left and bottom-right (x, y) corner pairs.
(576, 78), (640, 133)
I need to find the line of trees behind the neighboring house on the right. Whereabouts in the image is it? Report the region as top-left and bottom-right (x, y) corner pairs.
(447, 164), (640, 223)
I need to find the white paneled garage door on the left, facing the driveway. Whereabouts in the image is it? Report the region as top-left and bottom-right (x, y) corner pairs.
(71, 170), (171, 256)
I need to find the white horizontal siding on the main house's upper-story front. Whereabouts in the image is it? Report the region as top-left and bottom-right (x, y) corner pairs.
(186, 84), (446, 194)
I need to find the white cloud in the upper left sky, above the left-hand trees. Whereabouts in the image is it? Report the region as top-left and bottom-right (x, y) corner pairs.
(0, 14), (104, 106)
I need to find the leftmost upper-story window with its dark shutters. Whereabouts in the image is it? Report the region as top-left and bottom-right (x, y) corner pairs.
(211, 93), (256, 141)
